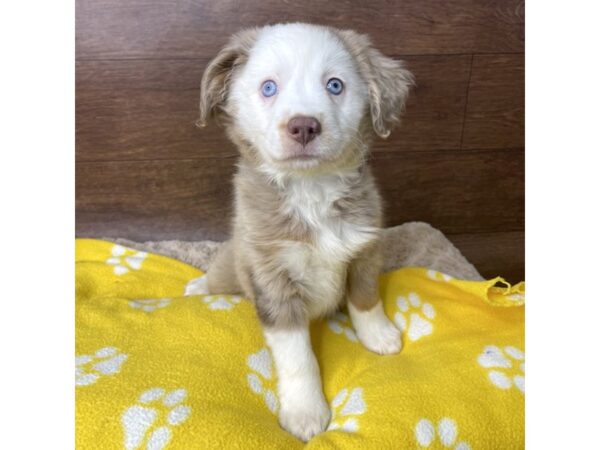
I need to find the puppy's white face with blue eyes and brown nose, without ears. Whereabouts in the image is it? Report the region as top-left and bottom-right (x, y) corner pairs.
(229, 25), (369, 169)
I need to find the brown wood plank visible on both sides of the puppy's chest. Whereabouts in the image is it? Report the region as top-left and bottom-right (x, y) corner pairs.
(76, 150), (524, 240)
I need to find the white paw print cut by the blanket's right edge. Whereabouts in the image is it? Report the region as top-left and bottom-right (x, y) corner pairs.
(477, 345), (525, 392)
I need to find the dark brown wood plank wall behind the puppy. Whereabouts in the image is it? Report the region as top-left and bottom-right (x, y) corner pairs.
(76, 0), (524, 281)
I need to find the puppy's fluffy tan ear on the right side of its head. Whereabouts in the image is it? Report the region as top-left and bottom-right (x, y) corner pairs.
(338, 30), (415, 138)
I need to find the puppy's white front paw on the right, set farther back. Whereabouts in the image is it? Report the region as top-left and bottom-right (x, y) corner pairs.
(348, 302), (402, 355)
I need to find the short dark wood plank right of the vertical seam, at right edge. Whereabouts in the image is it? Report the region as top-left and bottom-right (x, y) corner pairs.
(462, 54), (525, 148)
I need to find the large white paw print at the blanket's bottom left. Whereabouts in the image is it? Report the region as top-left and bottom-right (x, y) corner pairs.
(121, 388), (192, 450)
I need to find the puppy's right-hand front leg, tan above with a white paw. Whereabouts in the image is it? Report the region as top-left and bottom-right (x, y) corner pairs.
(348, 245), (402, 355)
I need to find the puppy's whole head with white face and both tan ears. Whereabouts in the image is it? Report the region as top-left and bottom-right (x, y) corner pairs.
(199, 24), (413, 172)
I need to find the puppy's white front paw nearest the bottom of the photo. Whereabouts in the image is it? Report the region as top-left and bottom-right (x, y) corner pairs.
(279, 395), (331, 442)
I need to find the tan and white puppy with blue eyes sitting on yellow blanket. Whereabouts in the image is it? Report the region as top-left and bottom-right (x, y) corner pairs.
(199, 23), (413, 441)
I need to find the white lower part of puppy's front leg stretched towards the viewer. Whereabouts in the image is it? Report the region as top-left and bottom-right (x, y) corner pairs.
(264, 325), (330, 441)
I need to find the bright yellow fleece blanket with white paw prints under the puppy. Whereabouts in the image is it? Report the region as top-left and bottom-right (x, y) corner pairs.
(75, 239), (525, 450)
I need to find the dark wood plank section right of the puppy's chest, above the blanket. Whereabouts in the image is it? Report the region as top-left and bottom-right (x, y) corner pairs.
(372, 149), (525, 233)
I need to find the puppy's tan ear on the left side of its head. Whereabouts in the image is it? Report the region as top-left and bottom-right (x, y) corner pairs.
(196, 28), (258, 127)
